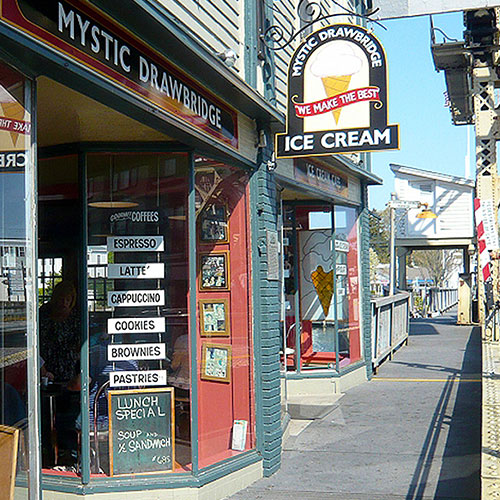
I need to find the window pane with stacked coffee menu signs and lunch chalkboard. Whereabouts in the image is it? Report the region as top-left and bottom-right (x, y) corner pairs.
(87, 153), (192, 475)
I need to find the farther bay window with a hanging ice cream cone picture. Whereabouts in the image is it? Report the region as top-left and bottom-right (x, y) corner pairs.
(282, 204), (361, 370)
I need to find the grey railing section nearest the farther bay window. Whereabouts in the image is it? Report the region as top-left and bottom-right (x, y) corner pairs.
(371, 292), (411, 369)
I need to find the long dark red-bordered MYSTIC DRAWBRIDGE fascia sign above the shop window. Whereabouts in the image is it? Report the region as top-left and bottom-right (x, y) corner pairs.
(0, 0), (238, 149)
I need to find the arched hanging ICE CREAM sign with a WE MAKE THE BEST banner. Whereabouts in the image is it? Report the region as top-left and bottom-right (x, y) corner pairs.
(276, 24), (399, 158)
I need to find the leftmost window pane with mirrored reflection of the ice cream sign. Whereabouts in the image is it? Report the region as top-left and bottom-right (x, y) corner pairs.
(0, 63), (36, 492)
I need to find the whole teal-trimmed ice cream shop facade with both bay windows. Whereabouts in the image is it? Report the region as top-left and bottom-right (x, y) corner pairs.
(0, 0), (379, 499)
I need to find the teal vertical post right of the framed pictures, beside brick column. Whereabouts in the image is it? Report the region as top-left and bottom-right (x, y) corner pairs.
(250, 173), (264, 453)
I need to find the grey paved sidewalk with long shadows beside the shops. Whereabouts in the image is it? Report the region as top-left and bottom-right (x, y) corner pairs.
(231, 314), (481, 500)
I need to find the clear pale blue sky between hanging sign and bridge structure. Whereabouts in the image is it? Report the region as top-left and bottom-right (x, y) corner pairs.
(369, 12), (475, 210)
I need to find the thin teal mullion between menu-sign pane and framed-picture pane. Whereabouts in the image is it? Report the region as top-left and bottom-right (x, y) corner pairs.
(188, 154), (199, 475)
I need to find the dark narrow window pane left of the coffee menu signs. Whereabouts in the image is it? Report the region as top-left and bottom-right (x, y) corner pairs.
(38, 155), (83, 476)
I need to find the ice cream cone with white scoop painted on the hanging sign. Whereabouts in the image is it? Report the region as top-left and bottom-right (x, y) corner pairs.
(311, 41), (363, 124)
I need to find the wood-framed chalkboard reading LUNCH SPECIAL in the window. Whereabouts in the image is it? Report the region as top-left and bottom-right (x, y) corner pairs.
(108, 387), (175, 476)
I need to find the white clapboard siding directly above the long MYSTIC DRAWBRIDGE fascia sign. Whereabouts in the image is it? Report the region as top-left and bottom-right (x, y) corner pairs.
(158, 0), (244, 72)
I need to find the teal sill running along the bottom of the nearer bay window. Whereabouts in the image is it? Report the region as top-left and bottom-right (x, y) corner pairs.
(43, 450), (262, 495)
